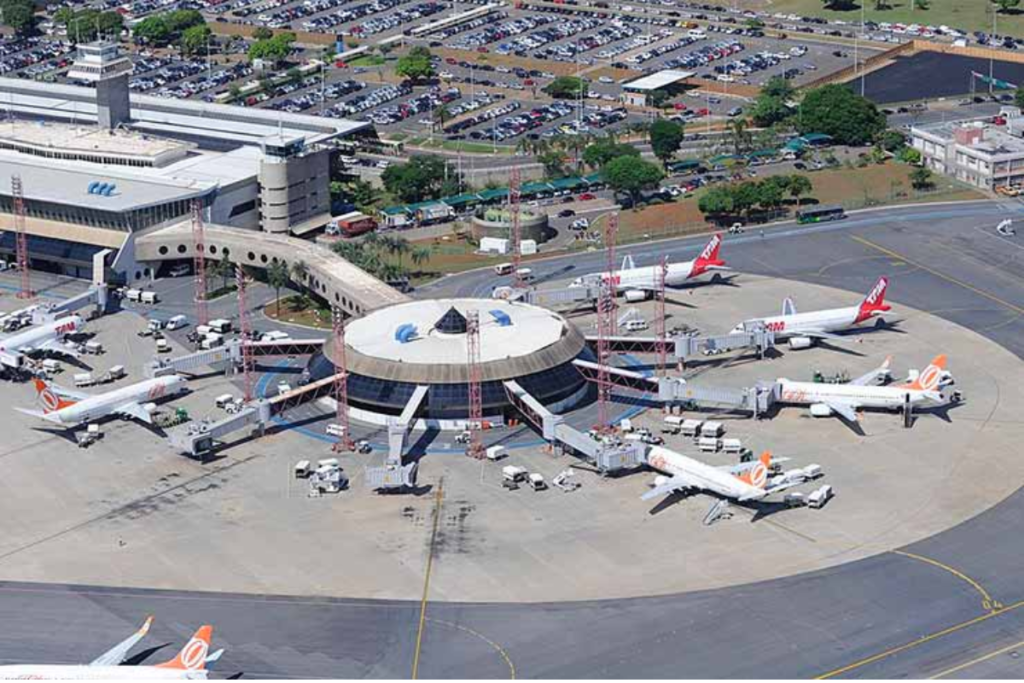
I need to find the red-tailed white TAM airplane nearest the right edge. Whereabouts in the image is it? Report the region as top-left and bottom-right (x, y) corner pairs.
(732, 278), (892, 349)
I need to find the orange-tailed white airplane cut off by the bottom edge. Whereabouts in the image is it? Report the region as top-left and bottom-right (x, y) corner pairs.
(0, 616), (224, 681)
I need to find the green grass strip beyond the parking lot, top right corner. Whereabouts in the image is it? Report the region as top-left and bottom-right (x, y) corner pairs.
(711, 0), (1011, 36)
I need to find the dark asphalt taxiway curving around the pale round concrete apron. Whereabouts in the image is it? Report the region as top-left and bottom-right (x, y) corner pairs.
(0, 197), (1024, 678)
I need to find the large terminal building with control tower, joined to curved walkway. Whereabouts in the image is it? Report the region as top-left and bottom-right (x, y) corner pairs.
(0, 43), (375, 281)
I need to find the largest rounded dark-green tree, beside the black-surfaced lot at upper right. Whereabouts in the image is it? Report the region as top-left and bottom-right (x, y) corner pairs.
(798, 84), (886, 145)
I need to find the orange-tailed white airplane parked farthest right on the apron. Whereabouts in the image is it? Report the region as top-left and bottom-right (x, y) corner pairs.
(778, 354), (952, 423)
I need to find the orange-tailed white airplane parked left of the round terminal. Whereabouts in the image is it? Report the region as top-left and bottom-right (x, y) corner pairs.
(14, 375), (187, 427)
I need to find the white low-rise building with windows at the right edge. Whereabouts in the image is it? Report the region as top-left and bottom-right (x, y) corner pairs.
(910, 112), (1024, 189)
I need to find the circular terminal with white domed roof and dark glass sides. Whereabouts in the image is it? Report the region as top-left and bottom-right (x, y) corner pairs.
(309, 299), (593, 420)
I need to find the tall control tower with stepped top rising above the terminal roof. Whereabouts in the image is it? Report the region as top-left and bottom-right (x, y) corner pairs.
(68, 41), (132, 130)
